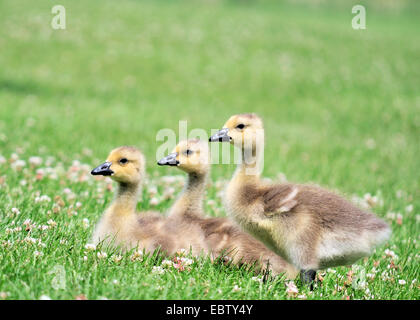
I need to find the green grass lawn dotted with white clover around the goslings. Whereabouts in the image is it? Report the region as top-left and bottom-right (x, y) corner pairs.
(0, 0), (420, 299)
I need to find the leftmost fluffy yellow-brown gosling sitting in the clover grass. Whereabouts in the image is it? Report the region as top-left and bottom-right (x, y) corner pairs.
(91, 146), (207, 256)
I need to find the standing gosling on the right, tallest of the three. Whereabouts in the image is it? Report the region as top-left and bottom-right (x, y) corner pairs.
(209, 114), (391, 288)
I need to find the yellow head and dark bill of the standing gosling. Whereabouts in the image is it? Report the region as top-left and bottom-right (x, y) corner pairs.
(209, 113), (264, 150)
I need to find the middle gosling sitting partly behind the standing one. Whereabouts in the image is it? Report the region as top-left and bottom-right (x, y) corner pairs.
(158, 140), (299, 279)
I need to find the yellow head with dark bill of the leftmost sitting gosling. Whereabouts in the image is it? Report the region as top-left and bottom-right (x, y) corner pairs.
(91, 147), (145, 184)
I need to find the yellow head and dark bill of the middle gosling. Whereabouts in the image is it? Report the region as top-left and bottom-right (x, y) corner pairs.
(158, 139), (210, 174)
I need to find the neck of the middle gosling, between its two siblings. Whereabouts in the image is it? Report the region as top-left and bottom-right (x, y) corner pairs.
(169, 172), (208, 216)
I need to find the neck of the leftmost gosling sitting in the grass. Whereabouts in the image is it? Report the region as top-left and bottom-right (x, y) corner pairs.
(112, 182), (141, 215)
